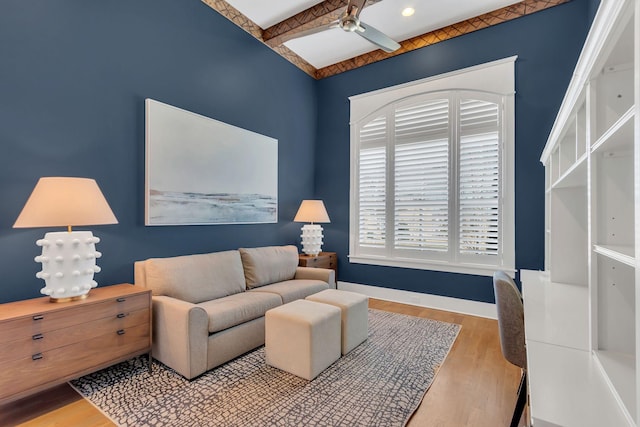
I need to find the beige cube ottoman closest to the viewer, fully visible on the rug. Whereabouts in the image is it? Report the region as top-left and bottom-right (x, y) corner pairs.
(265, 300), (340, 380)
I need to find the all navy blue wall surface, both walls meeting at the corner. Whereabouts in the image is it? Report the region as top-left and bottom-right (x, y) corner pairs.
(0, 0), (597, 308)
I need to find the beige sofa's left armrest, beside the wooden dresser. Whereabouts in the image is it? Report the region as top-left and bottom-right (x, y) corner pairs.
(152, 296), (209, 379)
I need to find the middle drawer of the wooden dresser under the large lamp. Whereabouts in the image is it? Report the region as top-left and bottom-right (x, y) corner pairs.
(0, 308), (151, 365)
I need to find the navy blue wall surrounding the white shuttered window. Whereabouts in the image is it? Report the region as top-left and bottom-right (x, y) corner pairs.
(316, 0), (594, 302)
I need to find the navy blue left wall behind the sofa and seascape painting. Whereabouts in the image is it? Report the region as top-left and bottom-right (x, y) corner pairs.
(0, 0), (317, 302)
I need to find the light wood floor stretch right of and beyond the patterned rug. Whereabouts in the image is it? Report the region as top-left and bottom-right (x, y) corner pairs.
(369, 299), (520, 427)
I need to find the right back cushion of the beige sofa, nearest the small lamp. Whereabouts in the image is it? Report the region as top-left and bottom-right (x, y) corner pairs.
(240, 246), (298, 289)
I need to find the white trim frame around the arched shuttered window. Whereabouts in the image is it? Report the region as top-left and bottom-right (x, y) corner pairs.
(349, 56), (517, 276)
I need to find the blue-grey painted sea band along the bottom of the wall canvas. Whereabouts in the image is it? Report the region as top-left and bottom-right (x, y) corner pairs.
(149, 189), (278, 225)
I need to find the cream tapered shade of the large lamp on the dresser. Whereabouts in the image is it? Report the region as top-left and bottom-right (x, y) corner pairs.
(13, 177), (118, 228)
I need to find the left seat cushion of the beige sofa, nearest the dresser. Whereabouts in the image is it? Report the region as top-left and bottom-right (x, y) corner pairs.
(198, 292), (282, 334)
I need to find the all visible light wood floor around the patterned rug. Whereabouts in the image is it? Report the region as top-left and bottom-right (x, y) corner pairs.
(0, 299), (520, 427)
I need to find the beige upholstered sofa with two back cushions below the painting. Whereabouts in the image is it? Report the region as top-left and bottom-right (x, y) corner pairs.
(135, 246), (335, 379)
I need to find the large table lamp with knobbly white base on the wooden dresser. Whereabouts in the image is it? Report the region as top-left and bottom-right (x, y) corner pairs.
(13, 177), (118, 302)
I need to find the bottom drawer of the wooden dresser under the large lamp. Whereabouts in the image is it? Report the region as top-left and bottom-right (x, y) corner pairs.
(0, 323), (151, 400)
